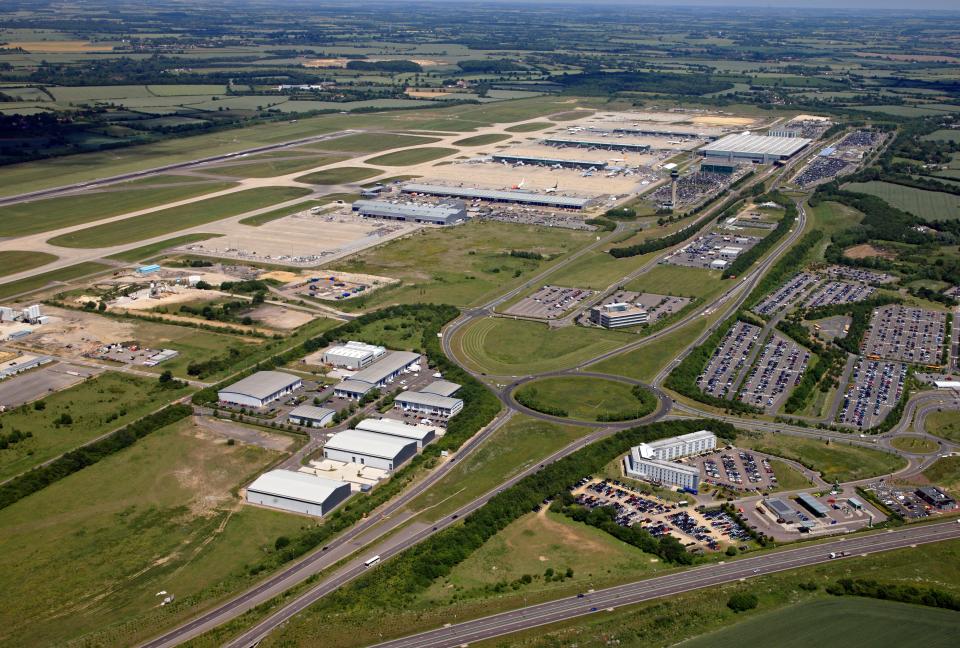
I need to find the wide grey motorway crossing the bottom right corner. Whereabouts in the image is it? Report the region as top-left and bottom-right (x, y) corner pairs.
(377, 522), (960, 648)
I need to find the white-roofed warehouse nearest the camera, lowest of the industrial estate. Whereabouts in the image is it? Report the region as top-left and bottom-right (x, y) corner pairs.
(247, 470), (350, 517)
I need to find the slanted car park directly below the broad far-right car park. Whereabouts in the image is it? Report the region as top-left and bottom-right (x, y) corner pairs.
(837, 358), (907, 430)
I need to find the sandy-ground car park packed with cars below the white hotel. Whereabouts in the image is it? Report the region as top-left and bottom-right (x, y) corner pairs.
(573, 479), (750, 551)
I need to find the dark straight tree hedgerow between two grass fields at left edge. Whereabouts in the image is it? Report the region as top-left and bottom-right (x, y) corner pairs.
(0, 404), (193, 508)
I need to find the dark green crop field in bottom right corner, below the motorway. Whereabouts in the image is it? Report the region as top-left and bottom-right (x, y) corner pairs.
(681, 597), (960, 648)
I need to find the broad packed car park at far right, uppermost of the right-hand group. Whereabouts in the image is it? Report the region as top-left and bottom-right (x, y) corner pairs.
(863, 304), (947, 365)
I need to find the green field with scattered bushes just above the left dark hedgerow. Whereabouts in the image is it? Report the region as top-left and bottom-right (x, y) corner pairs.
(0, 372), (184, 481)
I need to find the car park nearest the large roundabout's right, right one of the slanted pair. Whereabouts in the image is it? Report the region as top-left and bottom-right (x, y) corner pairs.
(738, 333), (810, 412)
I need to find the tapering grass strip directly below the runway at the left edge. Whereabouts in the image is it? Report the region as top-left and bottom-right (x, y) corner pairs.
(0, 182), (234, 236)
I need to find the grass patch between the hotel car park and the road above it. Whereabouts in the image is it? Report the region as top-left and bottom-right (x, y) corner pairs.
(736, 434), (906, 482)
